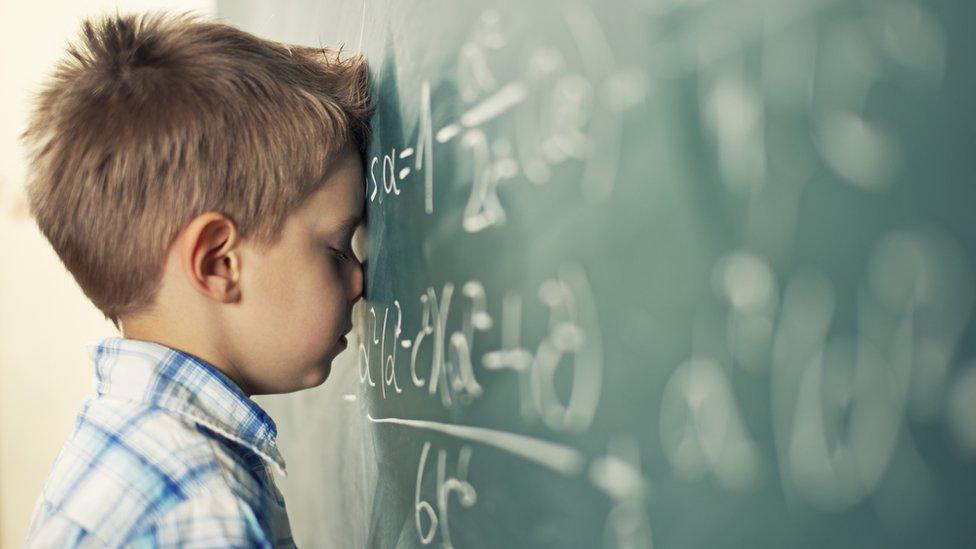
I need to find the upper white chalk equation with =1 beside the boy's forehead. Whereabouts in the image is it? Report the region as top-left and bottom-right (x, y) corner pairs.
(365, 8), (646, 233)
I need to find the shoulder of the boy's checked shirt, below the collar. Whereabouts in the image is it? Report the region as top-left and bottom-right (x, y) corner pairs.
(28, 398), (274, 546)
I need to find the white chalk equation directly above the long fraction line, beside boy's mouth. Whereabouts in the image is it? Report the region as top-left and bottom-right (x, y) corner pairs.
(357, 264), (604, 432)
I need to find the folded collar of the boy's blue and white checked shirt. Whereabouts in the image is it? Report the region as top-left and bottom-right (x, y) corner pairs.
(86, 337), (287, 476)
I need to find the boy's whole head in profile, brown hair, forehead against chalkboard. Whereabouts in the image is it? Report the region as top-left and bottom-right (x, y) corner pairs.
(22, 13), (372, 394)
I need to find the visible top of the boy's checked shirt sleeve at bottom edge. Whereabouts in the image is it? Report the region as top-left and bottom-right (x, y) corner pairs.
(126, 495), (272, 549)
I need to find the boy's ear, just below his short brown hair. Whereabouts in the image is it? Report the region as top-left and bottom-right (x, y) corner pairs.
(179, 212), (241, 303)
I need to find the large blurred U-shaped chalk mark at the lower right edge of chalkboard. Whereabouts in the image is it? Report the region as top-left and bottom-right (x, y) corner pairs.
(772, 229), (973, 510)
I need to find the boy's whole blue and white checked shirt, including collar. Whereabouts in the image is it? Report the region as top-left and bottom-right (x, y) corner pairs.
(26, 337), (295, 547)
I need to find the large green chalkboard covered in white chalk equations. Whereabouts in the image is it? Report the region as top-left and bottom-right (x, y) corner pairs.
(218, 0), (976, 548)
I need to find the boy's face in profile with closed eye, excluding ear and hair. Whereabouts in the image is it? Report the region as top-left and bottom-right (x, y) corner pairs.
(226, 148), (365, 394)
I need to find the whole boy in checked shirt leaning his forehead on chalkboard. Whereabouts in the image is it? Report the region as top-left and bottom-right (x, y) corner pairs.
(23, 13), (372, 547)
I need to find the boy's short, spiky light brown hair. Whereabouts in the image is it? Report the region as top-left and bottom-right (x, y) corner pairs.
(21, 12), (373, 327)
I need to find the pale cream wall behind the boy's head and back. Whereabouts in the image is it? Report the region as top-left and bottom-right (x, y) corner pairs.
(0, 0), (214, 548)
